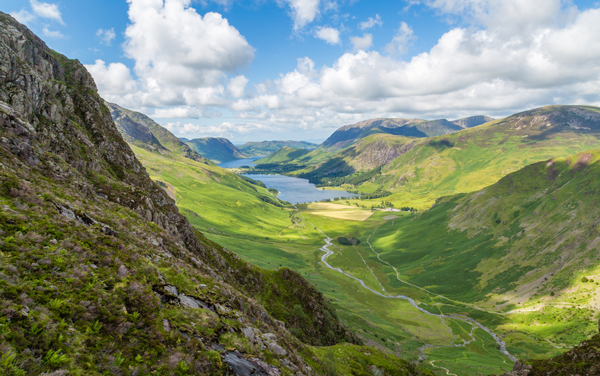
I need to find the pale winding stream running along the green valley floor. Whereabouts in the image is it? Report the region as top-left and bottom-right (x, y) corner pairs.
(311, 223), (517, 367)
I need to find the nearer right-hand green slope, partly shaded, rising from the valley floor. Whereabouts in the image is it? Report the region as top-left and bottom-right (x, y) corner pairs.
(370, 150), (600, 358)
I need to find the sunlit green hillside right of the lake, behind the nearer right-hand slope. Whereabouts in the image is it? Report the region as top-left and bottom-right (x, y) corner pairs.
(283, 106), (600, 209)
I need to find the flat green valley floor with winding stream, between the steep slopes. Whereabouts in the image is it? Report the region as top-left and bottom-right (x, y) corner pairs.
(203, 200), (594, 375)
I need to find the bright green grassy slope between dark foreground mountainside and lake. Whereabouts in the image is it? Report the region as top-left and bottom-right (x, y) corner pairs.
(132, 146), (289, 237)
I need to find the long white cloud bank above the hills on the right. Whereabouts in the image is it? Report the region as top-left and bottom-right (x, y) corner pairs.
(214, 0), (600, 135)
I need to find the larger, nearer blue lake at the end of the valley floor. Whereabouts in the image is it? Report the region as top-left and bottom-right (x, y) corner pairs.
(244, 174), (359, 204)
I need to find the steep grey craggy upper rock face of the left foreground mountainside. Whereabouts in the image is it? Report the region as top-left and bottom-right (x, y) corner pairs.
(0, 14), (203, 258)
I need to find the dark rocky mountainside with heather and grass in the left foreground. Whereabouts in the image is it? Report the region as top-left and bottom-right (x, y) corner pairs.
(0, 13), (426, 375)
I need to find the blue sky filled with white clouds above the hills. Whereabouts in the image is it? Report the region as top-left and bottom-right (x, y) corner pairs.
(0, 0), (600, 144)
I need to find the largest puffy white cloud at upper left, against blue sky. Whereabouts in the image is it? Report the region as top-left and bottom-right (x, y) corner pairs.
(124, 0), (254, 87)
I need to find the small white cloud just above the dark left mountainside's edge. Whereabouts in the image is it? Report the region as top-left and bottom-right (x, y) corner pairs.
(85, 59), (137, 94)
